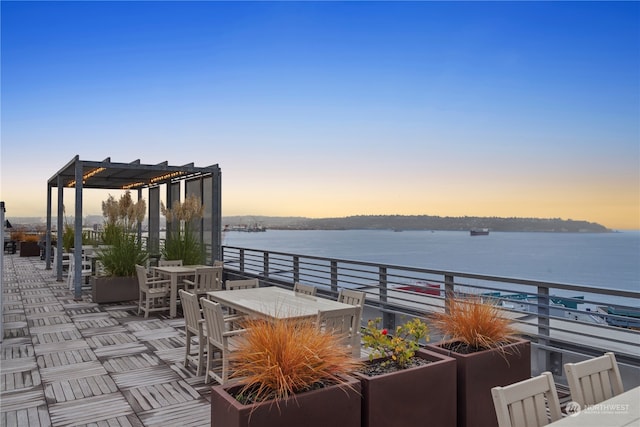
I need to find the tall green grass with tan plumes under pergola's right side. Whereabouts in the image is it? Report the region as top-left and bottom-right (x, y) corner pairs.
(160, 195), (205, 265)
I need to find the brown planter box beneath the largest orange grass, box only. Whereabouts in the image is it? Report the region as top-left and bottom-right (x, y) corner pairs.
(211, 377), (361, 427)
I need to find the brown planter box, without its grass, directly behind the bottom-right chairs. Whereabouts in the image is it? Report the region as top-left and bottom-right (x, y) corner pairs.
(427, 339), (531, 427)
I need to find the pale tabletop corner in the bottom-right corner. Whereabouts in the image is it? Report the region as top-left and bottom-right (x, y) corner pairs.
(548, 387), (640, 427)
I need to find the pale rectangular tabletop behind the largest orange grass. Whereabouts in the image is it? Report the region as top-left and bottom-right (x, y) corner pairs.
(207, 286), (352, 320)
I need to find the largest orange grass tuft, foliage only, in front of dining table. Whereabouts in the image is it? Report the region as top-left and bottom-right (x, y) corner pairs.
(230, 319), (361, 407)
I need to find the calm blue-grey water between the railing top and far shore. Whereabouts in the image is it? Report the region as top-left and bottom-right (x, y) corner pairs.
(223, 230), (640, 291)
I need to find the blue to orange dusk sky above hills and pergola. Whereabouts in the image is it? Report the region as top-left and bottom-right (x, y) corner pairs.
(0, 1), (640, 229)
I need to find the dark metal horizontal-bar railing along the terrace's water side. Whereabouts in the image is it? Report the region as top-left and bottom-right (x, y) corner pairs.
(222, 246), (640, 372)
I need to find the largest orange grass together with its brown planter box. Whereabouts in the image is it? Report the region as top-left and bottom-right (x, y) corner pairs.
(211, 319), (361, 427)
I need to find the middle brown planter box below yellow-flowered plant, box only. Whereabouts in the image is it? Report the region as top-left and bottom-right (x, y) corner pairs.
(353, 350), (456, 427)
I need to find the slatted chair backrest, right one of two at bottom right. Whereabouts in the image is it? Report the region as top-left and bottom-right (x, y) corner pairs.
(564, 352), (624, 407)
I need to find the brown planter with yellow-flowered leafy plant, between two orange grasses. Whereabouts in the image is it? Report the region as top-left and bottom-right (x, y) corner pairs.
(353, 318), (456, 427)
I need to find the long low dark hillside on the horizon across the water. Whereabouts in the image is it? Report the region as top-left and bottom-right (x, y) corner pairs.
(222, 215), (611, 233)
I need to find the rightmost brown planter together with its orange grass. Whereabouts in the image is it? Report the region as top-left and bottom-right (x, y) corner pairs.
(427, 297), (531, 427)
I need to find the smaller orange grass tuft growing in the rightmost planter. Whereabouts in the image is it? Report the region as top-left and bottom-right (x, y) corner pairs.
(430, 297), (517, 352)
